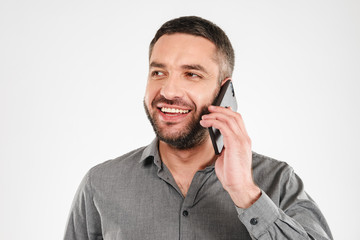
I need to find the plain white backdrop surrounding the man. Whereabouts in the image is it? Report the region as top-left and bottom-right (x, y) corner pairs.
(0, 0), (360, 239)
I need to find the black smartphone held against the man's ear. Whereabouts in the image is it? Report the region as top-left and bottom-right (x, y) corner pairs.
(208, 80), (237, 155)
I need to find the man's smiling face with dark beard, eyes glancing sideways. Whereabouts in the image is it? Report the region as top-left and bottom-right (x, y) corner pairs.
(144, 33), (220, 149)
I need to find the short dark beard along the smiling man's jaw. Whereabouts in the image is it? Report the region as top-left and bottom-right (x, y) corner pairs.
(144, 99), (208, 150)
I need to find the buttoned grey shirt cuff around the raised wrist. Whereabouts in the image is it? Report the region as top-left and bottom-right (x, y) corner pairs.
(235, 190), (280, 238)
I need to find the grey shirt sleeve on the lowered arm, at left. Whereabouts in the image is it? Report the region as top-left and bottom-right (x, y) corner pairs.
(64, 171), (103, 240)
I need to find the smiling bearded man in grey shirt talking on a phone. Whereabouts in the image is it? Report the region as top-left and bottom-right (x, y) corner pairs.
(65, 17), (332, 240)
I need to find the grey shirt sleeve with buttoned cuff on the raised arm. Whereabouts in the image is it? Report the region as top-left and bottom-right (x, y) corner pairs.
(237, 168), (333, 240)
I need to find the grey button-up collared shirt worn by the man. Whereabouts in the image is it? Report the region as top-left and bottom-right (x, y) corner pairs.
(64, 139), (332, 240)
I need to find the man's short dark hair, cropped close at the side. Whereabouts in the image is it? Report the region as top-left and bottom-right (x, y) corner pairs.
(149, 16), (235, 81)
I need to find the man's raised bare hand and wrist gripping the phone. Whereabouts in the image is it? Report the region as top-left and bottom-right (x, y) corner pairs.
(200, 106), (261, 208)
